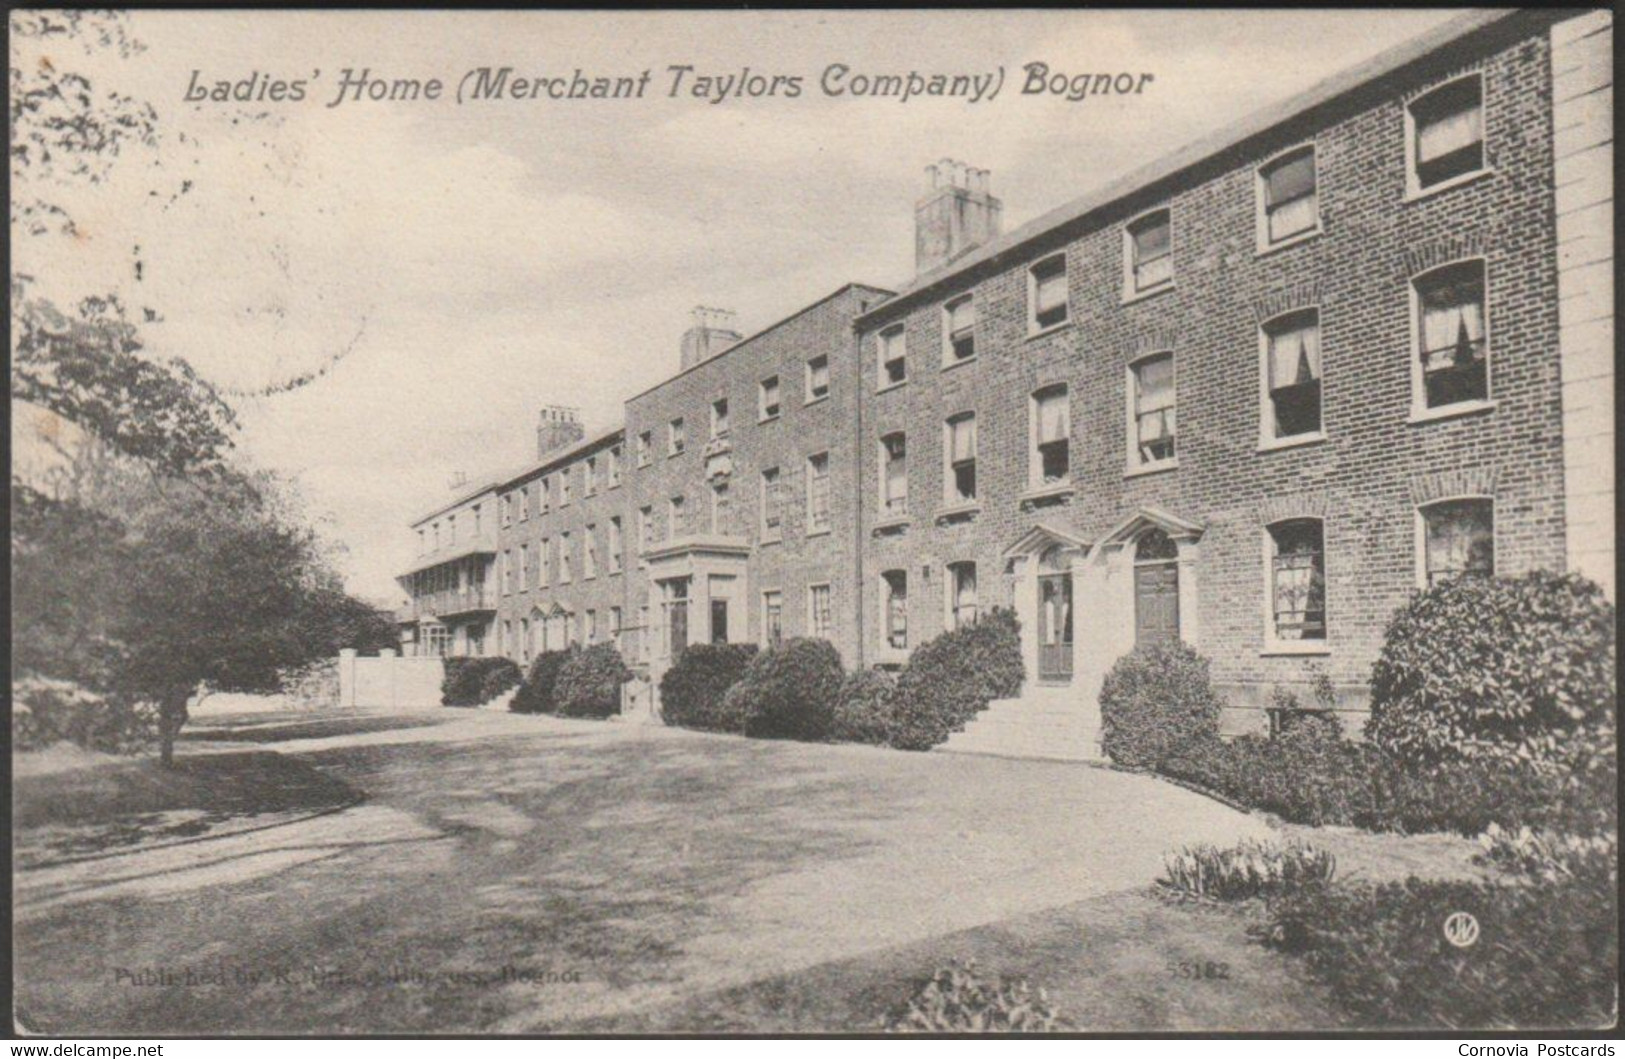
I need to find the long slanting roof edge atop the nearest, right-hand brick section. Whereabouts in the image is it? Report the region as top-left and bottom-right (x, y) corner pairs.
(853, 8), (1540, 330)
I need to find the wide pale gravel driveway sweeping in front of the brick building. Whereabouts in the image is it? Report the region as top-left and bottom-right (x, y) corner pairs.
(16, 711), (1268, 1035)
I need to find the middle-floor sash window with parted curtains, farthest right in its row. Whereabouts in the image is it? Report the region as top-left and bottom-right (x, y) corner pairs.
(1414, 262), (1490, 409)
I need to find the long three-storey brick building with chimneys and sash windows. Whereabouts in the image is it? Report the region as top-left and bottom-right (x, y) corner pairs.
(396, 11), (1614, 753)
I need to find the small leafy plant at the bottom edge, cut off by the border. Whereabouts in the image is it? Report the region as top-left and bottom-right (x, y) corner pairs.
(884, 960), (1069, 1033)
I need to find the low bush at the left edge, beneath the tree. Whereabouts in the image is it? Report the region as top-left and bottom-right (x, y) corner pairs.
(11, 676), (158, 754)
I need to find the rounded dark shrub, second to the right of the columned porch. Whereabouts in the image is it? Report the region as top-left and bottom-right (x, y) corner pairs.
(726, 637), (845, 739)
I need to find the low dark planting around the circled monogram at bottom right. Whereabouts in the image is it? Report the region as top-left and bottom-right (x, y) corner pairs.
(1264, 859), (1619, 1031)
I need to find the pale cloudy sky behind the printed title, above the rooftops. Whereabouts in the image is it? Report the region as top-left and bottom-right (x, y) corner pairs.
(13, 10), (1458, 603)
